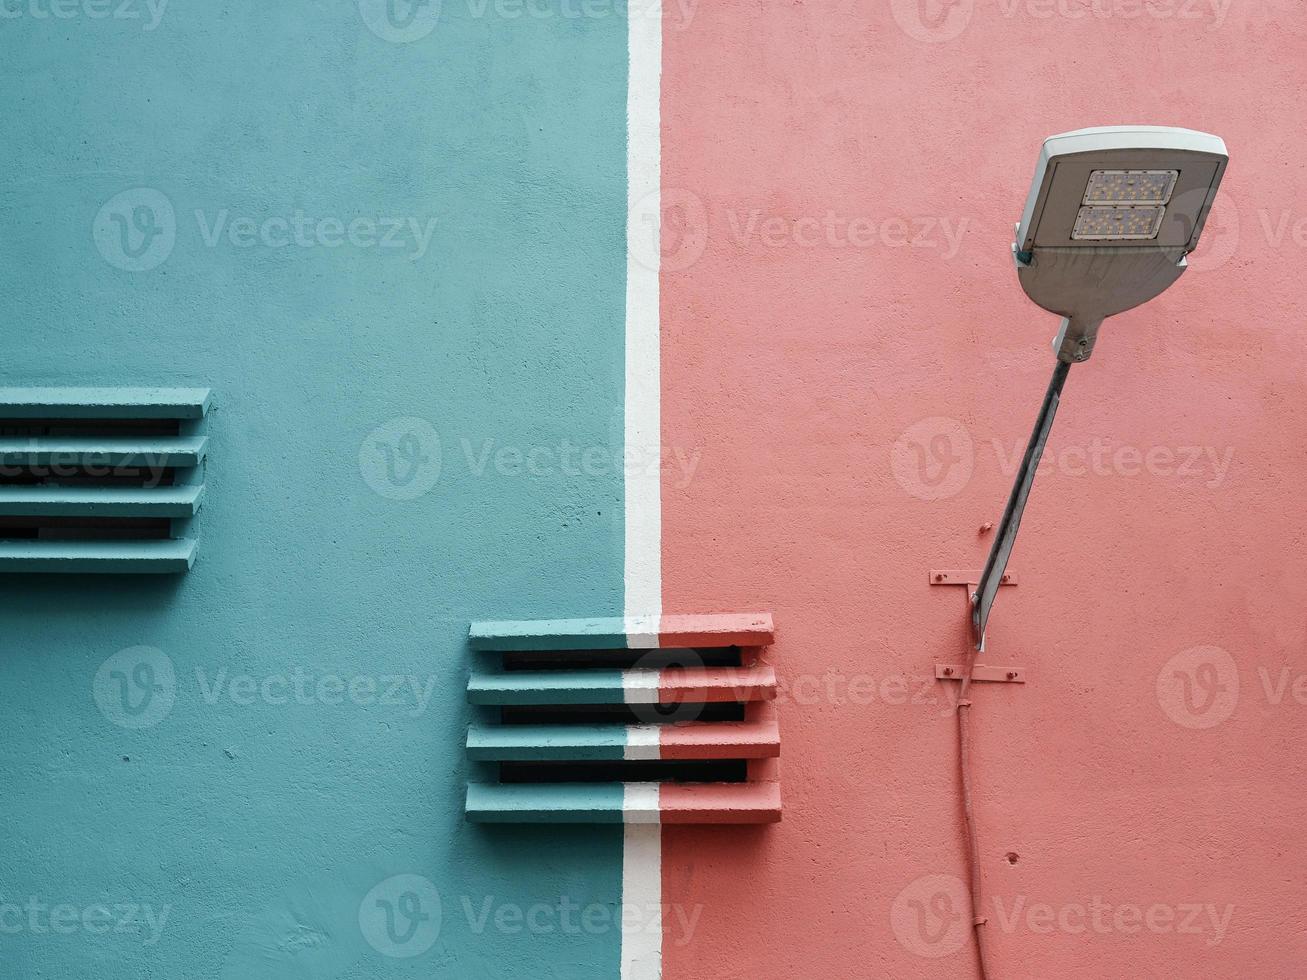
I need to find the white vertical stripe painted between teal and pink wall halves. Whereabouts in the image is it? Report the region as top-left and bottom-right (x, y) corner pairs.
(621, 0), (663, 980)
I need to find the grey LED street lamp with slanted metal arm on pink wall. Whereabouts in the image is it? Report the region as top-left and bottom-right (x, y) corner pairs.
(972, 125), (1230, 645)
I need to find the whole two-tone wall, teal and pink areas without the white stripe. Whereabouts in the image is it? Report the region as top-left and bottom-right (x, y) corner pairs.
(0, 0), (1307, 980)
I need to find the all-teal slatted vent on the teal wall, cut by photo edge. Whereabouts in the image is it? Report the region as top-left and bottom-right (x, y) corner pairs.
(0, 388), (209, 574)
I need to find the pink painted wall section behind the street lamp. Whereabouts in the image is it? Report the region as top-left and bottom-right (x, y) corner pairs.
(663, 0), (1307, 980)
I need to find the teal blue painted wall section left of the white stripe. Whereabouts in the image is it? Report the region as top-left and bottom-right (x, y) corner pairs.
(0, 0), (626, 980)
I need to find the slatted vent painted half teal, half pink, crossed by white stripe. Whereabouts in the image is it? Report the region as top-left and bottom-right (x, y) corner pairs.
(465, 614), (780, 823)
